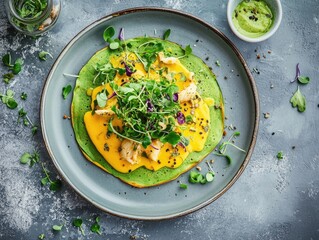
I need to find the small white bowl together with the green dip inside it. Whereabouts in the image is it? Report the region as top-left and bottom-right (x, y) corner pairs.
(227, 0), (282, 42)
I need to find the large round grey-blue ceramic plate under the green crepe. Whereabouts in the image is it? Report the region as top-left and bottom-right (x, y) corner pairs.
(40, 8), (259, 220)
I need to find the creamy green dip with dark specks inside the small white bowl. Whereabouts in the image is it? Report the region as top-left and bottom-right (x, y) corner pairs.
(232, 0), (274, 38)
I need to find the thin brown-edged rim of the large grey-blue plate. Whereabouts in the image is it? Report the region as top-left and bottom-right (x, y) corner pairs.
(39, 7), (260, 220)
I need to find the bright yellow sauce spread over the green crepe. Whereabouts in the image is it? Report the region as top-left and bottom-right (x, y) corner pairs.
(84, 53), (214, 173)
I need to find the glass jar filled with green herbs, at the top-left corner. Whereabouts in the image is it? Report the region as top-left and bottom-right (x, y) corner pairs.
(5, 0), (61, 36)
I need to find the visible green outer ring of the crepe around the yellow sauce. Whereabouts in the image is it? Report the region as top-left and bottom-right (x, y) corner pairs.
(71, 37), (224, 187)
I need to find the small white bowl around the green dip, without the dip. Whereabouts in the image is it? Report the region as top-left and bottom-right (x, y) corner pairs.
(227, 0), (282, 42)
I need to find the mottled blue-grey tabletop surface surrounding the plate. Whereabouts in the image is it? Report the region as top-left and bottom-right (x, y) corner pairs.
(0, 0), (319, 239)
